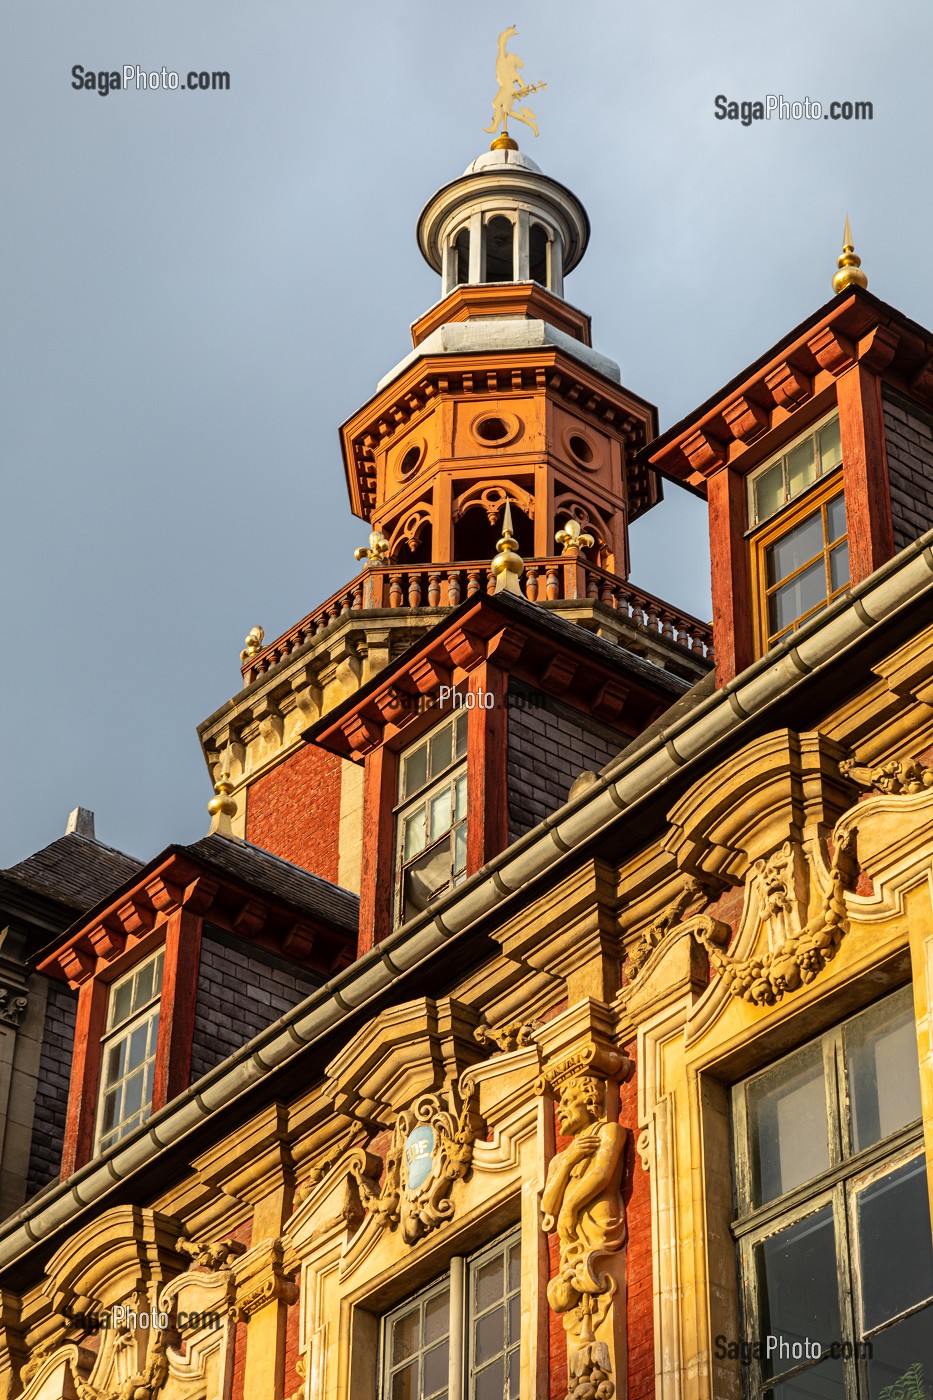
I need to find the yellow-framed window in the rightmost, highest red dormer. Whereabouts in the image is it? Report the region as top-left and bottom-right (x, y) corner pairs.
(748, 413), (849, 652)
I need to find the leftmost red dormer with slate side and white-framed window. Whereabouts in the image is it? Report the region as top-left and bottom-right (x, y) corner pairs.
(39, 834), (359, 1177)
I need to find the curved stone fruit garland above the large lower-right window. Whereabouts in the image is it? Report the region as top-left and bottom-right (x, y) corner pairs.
(689, 826), (857, 1007)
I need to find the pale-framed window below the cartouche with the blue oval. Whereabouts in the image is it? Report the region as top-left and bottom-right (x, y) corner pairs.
(380, 1231), (521, 1400)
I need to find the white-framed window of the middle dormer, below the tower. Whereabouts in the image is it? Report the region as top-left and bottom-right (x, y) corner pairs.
(395, 710), (467, 921)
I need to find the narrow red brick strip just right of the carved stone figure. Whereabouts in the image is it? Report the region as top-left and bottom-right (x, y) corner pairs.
(619, 1044), (654, 1400)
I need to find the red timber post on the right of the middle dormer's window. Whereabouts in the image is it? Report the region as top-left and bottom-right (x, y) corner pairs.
(467, 661), (509, 875)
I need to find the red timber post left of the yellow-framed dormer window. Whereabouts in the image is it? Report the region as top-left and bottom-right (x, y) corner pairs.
(709, 468), (755, 686)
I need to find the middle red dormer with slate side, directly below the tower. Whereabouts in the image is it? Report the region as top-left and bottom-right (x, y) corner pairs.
(304, 585), (691, 953)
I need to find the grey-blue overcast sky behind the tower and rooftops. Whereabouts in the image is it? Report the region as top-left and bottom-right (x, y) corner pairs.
(0, 0), (933, 865)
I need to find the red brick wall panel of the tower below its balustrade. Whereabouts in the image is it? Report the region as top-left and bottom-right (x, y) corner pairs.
(247, 743), (343, 883)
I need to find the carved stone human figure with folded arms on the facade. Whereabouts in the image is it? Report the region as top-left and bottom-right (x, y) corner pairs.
(538, 1046), (632, 1400)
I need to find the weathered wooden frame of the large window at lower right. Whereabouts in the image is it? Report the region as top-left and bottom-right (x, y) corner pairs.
(731, 984), (930, 1400)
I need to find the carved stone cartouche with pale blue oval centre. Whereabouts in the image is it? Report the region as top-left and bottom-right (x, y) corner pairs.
(349, 1082), (476, 1245)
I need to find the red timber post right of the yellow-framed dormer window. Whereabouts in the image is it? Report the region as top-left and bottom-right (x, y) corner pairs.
(836, 364), (894, 584)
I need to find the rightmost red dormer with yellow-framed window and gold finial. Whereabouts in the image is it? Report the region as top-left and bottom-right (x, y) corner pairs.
(640, 254), (933, 685)
